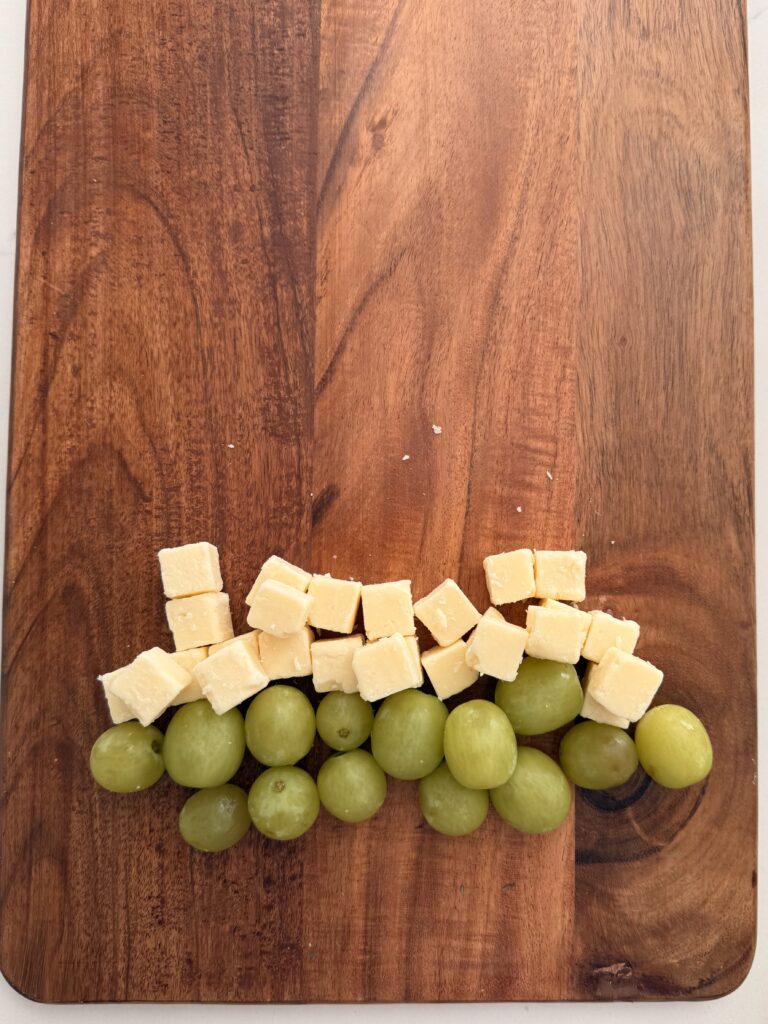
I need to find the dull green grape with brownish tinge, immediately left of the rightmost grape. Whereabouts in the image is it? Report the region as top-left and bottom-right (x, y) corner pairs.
(560, 722), (637, 790)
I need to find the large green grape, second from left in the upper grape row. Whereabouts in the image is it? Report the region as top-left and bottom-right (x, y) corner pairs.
(163, 700), (246, 790)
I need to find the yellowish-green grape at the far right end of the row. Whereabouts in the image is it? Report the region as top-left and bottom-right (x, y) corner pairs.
(635, 705), (712, 790)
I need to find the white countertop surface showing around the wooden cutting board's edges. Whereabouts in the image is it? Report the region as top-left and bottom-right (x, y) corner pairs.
(0, 0), (768, 1024)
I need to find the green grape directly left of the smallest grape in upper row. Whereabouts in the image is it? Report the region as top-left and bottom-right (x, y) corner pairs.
(246, 685), (314, 768)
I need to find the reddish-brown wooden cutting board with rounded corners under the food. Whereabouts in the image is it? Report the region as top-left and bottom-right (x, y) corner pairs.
(0, 0), (756, 1001)
